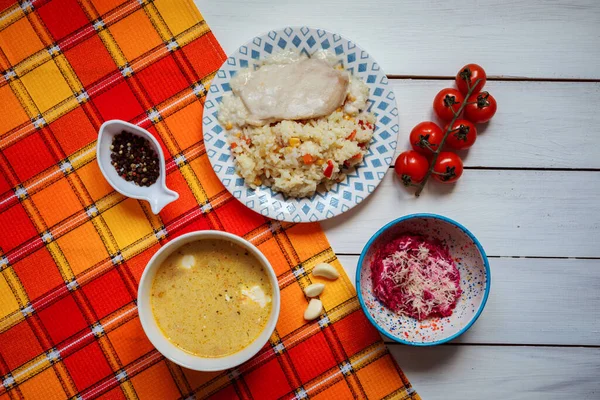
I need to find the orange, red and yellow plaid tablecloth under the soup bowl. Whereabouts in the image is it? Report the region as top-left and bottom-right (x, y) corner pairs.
(0, 0), (418, 400)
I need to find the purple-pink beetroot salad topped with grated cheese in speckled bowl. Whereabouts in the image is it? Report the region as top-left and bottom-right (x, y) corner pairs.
(371, 234), (462, 321)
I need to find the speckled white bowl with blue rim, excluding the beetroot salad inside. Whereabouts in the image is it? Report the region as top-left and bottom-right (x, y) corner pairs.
(356, 214), (491, 346)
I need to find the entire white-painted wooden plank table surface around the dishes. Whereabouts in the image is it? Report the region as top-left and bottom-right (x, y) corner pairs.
(196, 0), (600, 400)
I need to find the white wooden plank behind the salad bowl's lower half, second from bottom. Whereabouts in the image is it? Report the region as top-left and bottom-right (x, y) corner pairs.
(339, 256), (600, 346)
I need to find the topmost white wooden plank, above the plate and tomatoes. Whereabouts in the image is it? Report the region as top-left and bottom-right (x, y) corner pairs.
(195, 0), (600, 79)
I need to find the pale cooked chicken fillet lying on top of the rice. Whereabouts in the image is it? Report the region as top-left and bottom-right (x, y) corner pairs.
(232, 58), (349, 125)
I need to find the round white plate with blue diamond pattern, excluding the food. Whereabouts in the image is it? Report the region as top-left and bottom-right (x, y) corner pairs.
(203, 27), (399, 222)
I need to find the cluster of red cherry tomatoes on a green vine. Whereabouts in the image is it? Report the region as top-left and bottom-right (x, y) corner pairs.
(394, 64), (497, 195)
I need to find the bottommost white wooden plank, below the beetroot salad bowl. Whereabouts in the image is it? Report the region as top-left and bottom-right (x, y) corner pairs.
(390, 345), (600, 400)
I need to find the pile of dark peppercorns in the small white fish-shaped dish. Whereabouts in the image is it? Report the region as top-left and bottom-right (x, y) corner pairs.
(110, 131), (160, 186)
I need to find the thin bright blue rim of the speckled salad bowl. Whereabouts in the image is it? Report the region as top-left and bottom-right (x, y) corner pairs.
(356, 213), (492, 346)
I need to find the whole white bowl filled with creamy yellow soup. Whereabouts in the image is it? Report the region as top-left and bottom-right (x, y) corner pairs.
(138, 231), (280, 371)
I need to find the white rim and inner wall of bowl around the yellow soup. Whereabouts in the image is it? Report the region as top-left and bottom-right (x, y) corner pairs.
(137, 230), (280, 372)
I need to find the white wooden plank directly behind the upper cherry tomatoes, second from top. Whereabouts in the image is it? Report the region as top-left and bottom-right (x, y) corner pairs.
(390, 79), (600, 169)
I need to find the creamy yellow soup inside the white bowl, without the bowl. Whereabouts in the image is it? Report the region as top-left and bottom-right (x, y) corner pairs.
(151, 239), (271, 357)
